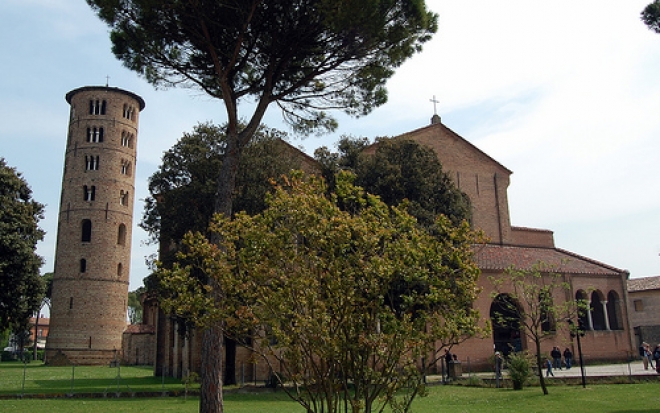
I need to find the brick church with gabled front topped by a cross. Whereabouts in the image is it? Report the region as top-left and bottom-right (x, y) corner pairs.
(131, 115), (635, 383)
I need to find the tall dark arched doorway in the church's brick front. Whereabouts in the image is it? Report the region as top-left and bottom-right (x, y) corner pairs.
(490, 294), (524, 355)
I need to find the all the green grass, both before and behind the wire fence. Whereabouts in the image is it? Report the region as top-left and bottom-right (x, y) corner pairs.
(0, 363), (660, 413)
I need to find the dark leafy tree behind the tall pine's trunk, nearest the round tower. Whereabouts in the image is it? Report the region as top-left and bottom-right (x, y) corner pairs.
(140, 123), (301, 384)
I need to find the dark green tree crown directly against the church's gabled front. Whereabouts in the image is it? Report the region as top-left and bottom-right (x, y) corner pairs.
(315, 136), (471, 228)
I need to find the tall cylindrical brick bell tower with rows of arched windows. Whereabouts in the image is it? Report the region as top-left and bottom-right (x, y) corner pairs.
(46, 86), (145, 365)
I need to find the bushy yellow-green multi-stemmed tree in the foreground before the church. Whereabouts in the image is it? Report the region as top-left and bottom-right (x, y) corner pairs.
(159, 172), (480, 413)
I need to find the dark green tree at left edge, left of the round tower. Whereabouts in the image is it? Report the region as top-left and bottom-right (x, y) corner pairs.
(0, 158), (44, 332)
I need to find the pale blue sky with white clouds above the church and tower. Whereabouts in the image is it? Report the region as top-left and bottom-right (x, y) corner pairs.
(0, 0), (660, 289)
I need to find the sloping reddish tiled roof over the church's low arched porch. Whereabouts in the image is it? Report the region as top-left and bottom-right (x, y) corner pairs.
(475, 244), (625, 275)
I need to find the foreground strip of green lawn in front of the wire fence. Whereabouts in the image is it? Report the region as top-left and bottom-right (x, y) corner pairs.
(0, 383), (660, 413)
